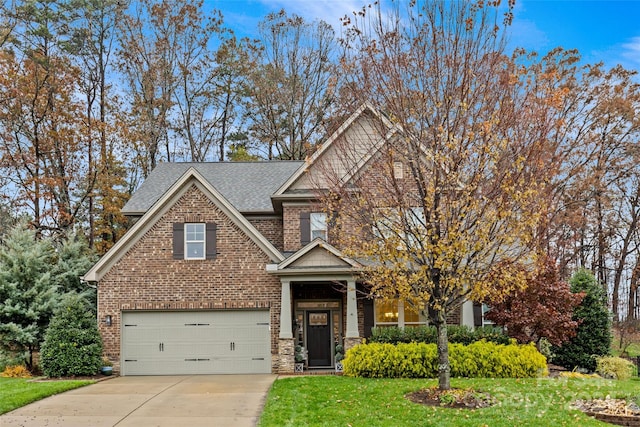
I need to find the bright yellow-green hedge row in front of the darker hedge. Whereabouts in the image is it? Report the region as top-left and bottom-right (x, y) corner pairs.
(342, 341), (547, 378)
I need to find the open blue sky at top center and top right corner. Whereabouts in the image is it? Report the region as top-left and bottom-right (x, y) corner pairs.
(205, 0), (640, 70)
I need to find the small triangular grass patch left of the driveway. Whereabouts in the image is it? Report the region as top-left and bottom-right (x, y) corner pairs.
(0, 377), (95, 414)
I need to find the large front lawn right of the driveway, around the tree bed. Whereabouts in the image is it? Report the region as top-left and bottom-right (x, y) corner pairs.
(258, 376), (640, 427)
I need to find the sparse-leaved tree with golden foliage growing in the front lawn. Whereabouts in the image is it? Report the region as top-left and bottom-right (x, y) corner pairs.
(314, 1), (564, 389)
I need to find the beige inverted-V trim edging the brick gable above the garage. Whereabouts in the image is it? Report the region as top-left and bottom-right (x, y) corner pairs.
(83, 168), (284, 281)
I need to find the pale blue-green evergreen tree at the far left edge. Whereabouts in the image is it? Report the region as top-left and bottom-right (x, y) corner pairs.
(0, 223), (60, 369)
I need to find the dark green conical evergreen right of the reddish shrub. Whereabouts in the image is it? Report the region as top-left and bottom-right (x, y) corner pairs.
(553, 269), (611, 371)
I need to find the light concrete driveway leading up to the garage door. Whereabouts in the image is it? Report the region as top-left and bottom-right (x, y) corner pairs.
(0, 375), (276, 427)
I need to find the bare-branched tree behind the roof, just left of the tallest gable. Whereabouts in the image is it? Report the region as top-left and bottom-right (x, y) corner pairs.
(245, 10), (337, 160)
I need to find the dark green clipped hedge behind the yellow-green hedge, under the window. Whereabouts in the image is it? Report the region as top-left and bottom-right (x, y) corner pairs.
(368, 326), (510, 345)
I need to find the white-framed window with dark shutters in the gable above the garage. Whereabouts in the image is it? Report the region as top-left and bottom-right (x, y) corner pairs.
(173, 222), (217, 260)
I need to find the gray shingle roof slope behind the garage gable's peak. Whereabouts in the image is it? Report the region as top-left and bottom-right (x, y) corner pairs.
(122, 161), (304, 214)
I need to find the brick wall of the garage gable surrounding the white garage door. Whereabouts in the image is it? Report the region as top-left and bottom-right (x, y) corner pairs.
(98, 186), (281, 371)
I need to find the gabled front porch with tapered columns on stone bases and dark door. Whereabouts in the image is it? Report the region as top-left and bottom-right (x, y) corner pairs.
(267, 238), (364, 373)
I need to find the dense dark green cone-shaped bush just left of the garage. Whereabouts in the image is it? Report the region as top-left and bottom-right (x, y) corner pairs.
(40, 295), (102, 377)
